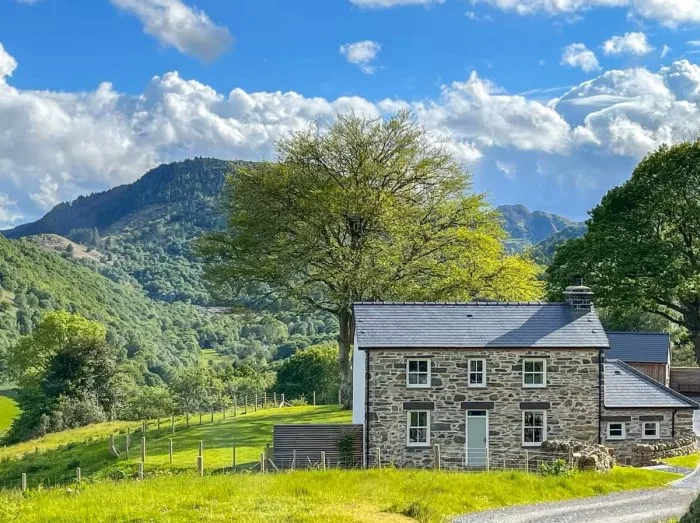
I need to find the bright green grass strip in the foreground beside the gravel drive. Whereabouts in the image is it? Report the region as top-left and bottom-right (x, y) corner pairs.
(0, 468), (677, 523)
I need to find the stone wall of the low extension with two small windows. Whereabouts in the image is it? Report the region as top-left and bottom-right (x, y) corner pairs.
(601, 408), (695, 465)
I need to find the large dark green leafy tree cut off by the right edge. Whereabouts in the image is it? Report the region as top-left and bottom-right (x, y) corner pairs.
(548, 141), (700, 363)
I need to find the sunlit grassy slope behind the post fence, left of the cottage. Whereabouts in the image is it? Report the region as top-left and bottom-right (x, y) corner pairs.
(0, 406), (351, 487)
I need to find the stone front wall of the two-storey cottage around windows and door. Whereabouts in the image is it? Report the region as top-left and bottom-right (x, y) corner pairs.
(367, 348), (599, 468)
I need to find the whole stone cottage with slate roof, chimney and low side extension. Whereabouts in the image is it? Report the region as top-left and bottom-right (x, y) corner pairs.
(353, 286), (699, 468)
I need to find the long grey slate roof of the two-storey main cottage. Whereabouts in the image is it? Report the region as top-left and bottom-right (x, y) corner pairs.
(354, 302), (609, 349)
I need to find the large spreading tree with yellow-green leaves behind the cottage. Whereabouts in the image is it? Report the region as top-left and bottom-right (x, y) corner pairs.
(200, 112), (541, 406)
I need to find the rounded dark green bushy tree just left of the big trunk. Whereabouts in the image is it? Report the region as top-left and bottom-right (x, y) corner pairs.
(275, 343), (340, 398)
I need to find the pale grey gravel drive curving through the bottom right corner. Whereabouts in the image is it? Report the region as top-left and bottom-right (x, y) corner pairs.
(454, 469), (700, 523)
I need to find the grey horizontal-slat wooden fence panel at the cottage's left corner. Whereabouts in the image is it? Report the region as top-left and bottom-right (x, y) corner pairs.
(273, 424), (363, 468)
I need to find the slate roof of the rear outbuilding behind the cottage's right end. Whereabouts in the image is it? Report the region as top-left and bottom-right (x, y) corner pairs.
(605, 332), (671, 363)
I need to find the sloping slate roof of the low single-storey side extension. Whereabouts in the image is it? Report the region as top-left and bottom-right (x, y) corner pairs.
(604, 360), (700, 409)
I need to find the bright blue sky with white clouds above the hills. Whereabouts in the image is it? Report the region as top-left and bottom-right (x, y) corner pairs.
(0, 0), (700, 228)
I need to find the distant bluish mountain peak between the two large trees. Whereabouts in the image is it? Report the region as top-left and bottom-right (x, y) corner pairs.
(497, 205), (585, 251)
